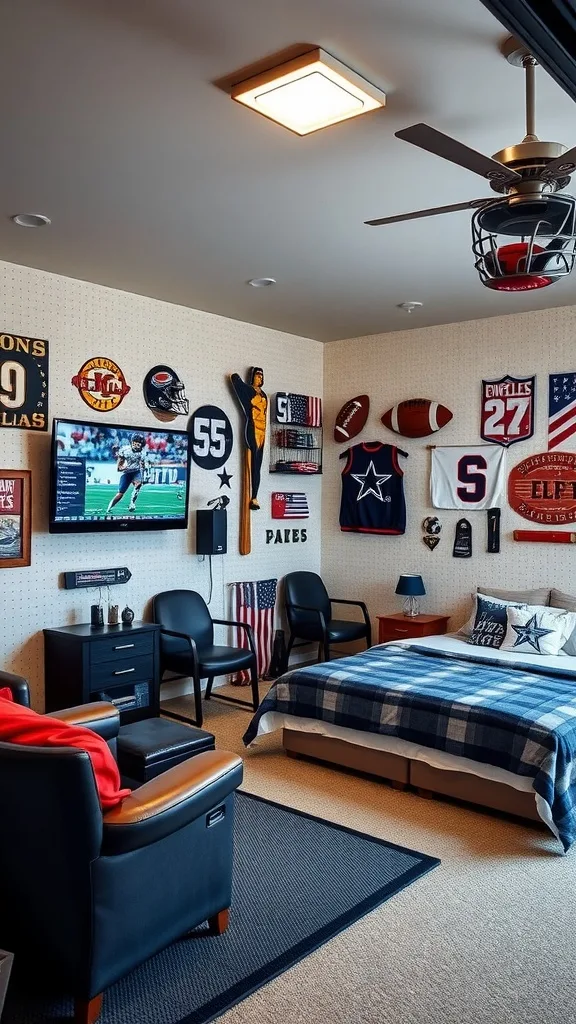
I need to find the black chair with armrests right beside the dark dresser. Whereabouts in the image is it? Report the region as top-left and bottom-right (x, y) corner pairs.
(152, 590), (259, 726)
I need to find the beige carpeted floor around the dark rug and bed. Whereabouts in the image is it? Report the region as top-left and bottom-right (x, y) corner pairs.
(159, 688), (576, 1024)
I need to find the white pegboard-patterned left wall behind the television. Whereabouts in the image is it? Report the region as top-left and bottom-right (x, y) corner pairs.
(0, 263), (323, 709)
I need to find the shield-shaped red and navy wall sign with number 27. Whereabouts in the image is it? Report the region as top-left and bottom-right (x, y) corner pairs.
(480, 375), (536, 447)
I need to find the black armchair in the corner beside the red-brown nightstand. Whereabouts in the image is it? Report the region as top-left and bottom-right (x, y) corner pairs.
(284, 572), (372, 662)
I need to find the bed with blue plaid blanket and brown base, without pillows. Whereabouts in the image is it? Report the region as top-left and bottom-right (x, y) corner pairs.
(244, 634), (576, 851)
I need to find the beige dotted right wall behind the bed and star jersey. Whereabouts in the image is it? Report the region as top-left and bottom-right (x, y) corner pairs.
(322, 298), (576, 625)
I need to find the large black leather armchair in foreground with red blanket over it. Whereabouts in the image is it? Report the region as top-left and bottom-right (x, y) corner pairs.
(0, 673), (242, 1024)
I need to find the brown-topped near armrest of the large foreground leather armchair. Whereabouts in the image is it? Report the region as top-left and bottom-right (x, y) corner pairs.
(102, 751), (243, 855)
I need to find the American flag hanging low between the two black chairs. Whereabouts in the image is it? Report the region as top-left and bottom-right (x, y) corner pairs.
(231, 580), (278, 686)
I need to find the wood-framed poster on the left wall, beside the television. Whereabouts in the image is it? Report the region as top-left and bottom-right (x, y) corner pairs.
(0, 469), (32, 569)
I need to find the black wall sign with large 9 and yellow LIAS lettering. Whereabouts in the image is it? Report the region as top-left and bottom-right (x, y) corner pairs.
(0, 334), (48, 430)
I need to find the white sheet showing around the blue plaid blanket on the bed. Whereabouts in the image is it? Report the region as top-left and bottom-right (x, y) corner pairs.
(250, 633), (576, 839)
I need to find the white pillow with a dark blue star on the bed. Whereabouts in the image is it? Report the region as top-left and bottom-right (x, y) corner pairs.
(500, 605), (576, 654)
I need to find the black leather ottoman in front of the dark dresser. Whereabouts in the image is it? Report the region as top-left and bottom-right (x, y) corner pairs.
(118, 718), (214, 783)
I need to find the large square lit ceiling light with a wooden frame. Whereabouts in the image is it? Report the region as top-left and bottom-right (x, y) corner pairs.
(232, 47), (386, 135)
